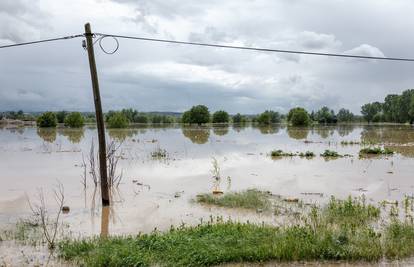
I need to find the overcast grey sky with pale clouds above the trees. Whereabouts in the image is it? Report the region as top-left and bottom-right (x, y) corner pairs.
(0, 0), (414, 114)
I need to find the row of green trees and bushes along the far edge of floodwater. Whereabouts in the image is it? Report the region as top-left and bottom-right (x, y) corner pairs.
(5, 89), (414, 128)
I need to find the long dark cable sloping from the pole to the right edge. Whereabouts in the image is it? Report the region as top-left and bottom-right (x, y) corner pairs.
(95, 33), (414, 62)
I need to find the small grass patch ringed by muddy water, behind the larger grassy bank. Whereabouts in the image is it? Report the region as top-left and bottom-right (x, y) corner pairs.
(196, 189), (271, 213)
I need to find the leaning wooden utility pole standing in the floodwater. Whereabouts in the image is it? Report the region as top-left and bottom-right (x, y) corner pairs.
(85, 23), (110, 206)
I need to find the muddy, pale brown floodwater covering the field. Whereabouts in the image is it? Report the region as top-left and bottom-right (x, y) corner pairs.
(0, 125), (414, 266)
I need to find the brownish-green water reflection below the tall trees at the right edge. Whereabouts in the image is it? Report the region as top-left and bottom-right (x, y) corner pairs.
(361, 125), (414, 144)
